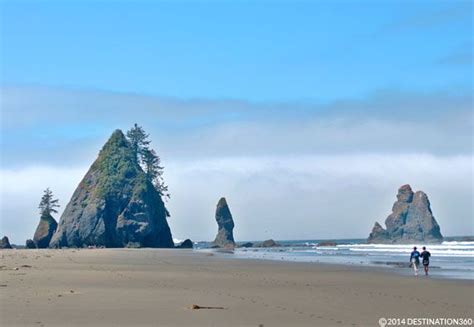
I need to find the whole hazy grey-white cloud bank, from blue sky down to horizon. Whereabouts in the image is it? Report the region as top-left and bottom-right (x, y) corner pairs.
(0, 86), (474, 244)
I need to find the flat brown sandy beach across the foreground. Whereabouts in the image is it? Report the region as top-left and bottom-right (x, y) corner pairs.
(0, 249), (474, 326)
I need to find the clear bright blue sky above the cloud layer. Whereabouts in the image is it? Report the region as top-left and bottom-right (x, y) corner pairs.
(1, 0), (473, 102)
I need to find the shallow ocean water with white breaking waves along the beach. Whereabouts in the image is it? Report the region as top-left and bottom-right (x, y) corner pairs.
(191, 237), (474, 280)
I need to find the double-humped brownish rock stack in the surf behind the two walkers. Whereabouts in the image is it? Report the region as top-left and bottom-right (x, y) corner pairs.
(367, 185), (443, 243)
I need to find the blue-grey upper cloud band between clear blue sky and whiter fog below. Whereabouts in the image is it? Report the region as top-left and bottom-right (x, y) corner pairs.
(0, 87), (473, 167)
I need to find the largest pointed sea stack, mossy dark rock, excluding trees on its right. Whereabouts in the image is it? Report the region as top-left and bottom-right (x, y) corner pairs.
(50, 130), (174, 248)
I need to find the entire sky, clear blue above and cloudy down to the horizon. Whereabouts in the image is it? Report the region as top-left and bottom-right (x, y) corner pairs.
(0, 0), (474, 244)
